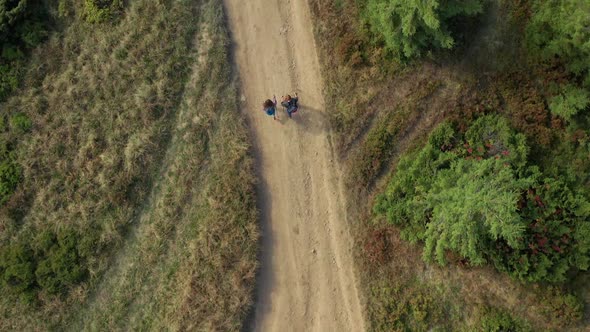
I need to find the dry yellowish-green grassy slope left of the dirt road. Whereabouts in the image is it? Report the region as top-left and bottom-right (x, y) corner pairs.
(0, 1), (258, 330)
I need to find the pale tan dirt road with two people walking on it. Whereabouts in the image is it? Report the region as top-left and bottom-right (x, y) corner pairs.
(225, 0), (364, 331)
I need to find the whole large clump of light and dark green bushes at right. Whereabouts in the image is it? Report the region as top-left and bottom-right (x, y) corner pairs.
(375, 116), (590, 282)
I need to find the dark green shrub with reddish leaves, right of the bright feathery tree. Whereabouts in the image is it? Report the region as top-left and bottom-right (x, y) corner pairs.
(492, 179), (590, 281)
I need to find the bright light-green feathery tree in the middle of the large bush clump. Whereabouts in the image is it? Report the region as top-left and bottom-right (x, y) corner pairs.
(424, 159), (536, 265)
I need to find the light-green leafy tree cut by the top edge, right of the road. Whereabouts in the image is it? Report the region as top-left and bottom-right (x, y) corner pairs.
(364, 0), (483, 59)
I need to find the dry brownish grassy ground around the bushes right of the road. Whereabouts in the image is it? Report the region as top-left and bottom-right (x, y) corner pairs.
(311, 0), (587, 331)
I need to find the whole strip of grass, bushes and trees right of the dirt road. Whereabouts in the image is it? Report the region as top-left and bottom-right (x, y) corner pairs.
(311, 0), (590, 331)
